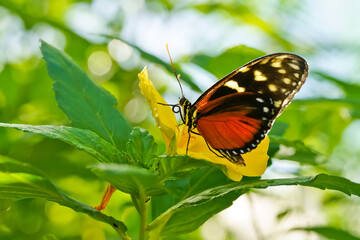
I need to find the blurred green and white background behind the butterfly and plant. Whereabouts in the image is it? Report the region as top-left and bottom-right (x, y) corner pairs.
(0, 0), (360, 240)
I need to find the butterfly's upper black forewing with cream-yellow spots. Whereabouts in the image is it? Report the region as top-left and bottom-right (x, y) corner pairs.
(193, 53), (308, 117)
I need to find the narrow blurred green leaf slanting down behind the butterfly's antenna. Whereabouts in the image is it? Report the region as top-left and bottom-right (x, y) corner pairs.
(102, 35), (201, 92)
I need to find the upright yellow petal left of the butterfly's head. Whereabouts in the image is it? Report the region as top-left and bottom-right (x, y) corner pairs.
(138, 67), (177, 155)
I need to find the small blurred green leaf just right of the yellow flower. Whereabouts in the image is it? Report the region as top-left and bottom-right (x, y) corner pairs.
(270, 135), (323, 165)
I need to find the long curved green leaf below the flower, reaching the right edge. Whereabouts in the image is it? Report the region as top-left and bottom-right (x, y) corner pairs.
(150, 174), (360, 236)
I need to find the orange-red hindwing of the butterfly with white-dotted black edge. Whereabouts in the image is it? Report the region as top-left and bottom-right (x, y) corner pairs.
(196, 93), (275, 163)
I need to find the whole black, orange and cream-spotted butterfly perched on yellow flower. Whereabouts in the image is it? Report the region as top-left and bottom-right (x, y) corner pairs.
(170, 53), (309, 165)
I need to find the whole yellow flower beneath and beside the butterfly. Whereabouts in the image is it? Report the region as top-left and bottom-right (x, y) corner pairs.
(139, 67), (269, 181)
